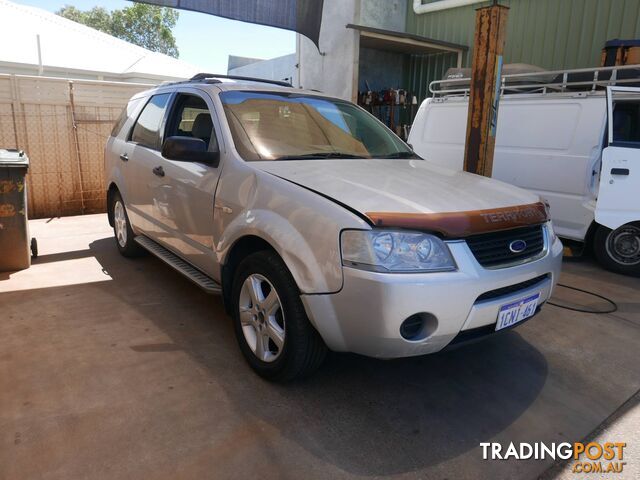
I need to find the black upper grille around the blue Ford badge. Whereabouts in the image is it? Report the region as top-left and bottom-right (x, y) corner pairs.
(466, 225), (544, 267)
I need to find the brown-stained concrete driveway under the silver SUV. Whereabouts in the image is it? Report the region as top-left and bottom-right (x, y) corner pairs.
(0, 215), (640, 479)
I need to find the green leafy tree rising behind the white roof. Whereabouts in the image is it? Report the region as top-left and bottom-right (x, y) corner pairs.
(56, 3), (179, 58)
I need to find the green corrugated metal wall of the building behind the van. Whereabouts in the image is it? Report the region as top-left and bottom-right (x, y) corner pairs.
(407, 0), (640, 100)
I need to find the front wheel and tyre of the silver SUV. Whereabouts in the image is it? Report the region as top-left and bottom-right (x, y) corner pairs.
(232, 251), (327, 382)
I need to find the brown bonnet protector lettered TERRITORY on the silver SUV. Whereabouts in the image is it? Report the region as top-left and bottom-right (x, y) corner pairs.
(365, 202), (549, 238)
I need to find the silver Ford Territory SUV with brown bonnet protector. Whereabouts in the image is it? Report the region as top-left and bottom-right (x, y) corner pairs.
(105, 74), (562, 381)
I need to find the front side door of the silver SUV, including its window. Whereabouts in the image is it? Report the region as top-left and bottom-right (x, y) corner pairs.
(151, 87), (222, 274)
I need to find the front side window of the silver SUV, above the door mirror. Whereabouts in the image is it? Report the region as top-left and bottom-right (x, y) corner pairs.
(165, 93), (217, 149)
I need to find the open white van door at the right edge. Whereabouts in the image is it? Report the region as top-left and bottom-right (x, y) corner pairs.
(596, 87), (640, 229)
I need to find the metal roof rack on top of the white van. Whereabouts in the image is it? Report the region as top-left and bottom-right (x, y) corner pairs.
(429, 65), (640, 97)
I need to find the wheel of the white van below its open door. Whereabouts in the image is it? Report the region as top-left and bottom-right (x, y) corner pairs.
(593, 222), (640, 276)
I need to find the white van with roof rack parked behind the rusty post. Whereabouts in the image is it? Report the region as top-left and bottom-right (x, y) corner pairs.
(408, 66), (640, 275)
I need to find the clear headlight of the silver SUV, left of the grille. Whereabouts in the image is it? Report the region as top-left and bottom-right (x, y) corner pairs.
(340, 230), (456, 272)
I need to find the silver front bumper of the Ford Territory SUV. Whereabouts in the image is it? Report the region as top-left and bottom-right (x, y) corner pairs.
(302, 231), (562, 358)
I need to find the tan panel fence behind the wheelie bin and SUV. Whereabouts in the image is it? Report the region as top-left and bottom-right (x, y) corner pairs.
(0, 74), (151, 218)
